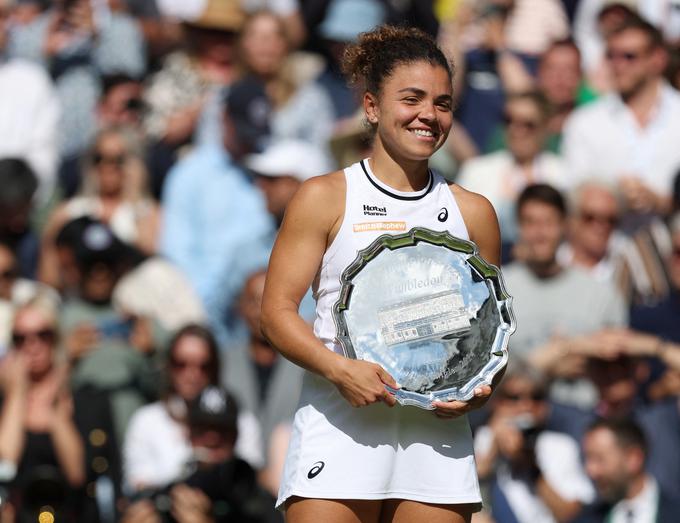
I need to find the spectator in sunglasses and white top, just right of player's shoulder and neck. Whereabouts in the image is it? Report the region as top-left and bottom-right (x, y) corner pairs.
(457, 91), (568, 245)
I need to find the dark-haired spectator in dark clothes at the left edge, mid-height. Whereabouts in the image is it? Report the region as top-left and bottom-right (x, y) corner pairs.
(0, 158), (40, 278)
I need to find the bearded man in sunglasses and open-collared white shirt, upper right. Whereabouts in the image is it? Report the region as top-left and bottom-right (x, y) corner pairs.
(563, 19), (680, 223)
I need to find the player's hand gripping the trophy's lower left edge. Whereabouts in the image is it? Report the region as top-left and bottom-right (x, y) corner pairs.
(330, 358), (399, 407)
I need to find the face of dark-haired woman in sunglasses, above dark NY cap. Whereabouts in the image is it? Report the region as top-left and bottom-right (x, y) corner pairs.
(170, 335), (211, 401)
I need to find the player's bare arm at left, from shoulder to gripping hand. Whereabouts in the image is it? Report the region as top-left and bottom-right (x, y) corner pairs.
(261, 172), (396, 406)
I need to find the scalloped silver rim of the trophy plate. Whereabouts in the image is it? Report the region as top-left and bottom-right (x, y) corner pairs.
(333, 227), (517, 410)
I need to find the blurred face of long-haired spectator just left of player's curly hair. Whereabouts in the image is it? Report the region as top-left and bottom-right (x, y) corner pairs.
(241, 14), (288, 76)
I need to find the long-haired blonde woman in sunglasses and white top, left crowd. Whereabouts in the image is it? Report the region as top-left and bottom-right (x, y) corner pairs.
(40, 128), (160, 286)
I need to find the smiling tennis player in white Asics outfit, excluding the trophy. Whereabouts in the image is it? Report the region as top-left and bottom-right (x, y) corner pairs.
(261, 26), (499, 523)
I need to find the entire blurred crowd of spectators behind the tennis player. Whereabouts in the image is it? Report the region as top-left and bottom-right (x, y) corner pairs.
(0, 0), (680, 523)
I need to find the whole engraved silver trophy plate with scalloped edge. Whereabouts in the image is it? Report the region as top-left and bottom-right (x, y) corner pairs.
(333, 227), (515, 409)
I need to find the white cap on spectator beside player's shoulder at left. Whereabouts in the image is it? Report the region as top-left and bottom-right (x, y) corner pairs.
(246, 140), (332, 182)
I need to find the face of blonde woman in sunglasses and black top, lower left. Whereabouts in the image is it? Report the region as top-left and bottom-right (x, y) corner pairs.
(12, 308), (57, 379)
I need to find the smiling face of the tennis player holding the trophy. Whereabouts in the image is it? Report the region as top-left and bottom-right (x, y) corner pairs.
(364, 61), (453, 161)
